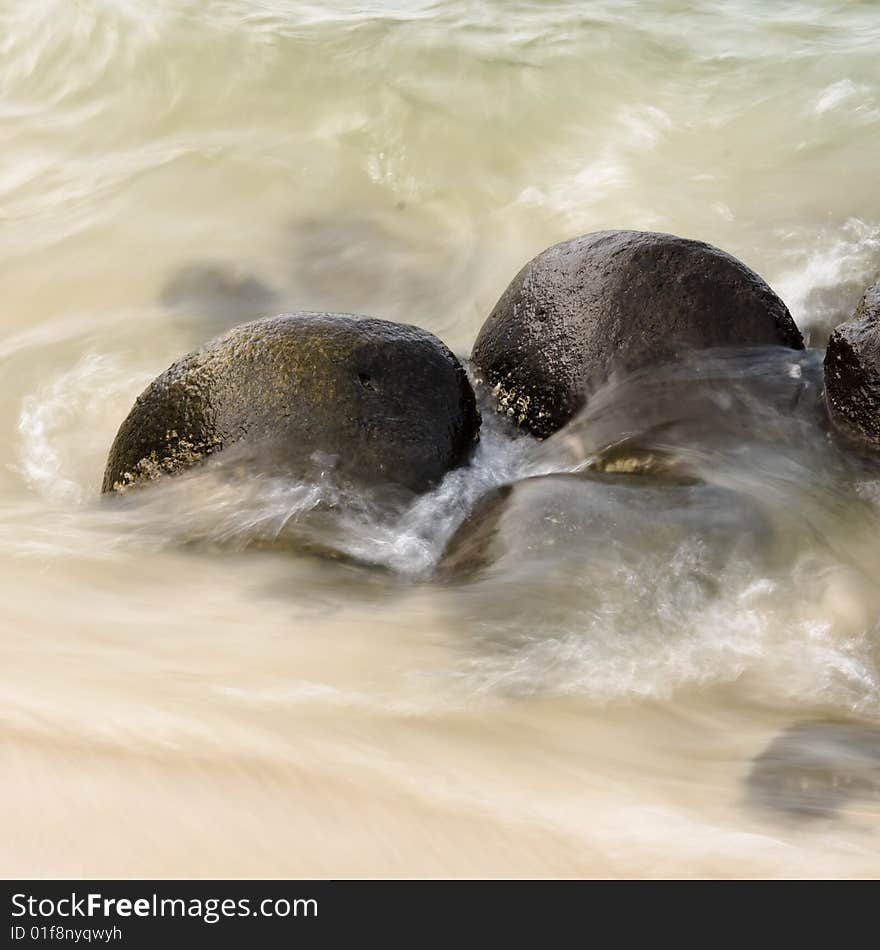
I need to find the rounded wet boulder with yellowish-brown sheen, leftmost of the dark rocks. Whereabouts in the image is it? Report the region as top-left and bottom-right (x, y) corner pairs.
(103, 313), (480, 492)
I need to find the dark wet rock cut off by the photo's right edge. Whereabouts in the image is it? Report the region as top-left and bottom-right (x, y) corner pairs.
(825, 281), (880, 448)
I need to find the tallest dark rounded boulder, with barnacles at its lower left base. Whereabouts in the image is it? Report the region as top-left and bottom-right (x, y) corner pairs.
(473, 231), (804, 438)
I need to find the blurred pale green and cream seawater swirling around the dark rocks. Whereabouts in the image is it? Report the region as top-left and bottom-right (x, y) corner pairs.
(0, 0), (880, 877)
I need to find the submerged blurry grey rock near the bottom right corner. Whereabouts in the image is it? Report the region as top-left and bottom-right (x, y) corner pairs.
(747, 720), (880, 818)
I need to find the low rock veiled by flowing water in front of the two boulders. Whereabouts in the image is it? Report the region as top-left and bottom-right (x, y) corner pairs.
(438, 469), (770, 590)
